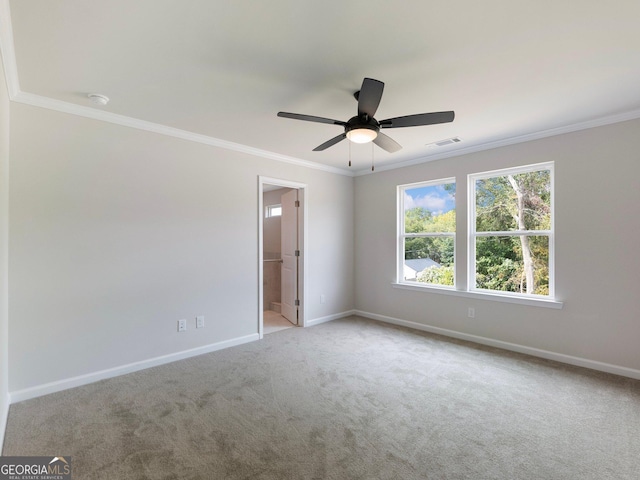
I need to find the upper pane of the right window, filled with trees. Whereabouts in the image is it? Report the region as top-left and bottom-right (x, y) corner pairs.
(475, 170), (551, 232)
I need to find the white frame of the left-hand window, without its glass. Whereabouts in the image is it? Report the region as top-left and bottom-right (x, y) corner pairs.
(396, 177), (458, 290)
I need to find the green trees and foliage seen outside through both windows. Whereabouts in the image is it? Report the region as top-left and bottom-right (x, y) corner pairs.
(405, 170), (551, 295)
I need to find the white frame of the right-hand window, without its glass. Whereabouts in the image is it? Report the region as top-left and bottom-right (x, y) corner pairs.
(467, 162), (555, 302)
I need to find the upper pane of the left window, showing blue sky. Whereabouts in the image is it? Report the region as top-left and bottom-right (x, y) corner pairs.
(404, 183), (456, 233)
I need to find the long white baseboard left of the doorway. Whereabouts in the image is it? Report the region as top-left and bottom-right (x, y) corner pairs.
(9, 333), (260, 403)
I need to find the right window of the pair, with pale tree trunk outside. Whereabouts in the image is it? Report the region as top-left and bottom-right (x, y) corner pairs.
(469, 163), (553, 297)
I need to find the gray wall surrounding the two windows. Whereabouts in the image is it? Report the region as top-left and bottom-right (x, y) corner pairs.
(355, 120), (640, 373)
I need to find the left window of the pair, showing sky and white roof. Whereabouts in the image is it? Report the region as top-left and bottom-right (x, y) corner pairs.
(398, 178), (456, 287)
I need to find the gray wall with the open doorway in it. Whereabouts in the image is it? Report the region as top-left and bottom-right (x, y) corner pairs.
(9, 104), (354, 397)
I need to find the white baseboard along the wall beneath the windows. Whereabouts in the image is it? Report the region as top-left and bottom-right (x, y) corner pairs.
(354, 310), (640, 380)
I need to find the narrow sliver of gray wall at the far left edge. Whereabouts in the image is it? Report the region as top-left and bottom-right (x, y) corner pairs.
(0, 45), (9, 452)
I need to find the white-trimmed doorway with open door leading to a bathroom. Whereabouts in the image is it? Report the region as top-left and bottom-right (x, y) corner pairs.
(258, 177), (306, 338)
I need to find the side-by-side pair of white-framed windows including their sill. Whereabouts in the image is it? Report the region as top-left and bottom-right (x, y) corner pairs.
(395, 162), (562, 308)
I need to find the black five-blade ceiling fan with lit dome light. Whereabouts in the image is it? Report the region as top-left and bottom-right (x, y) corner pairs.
(278, 78), (455, 153)
